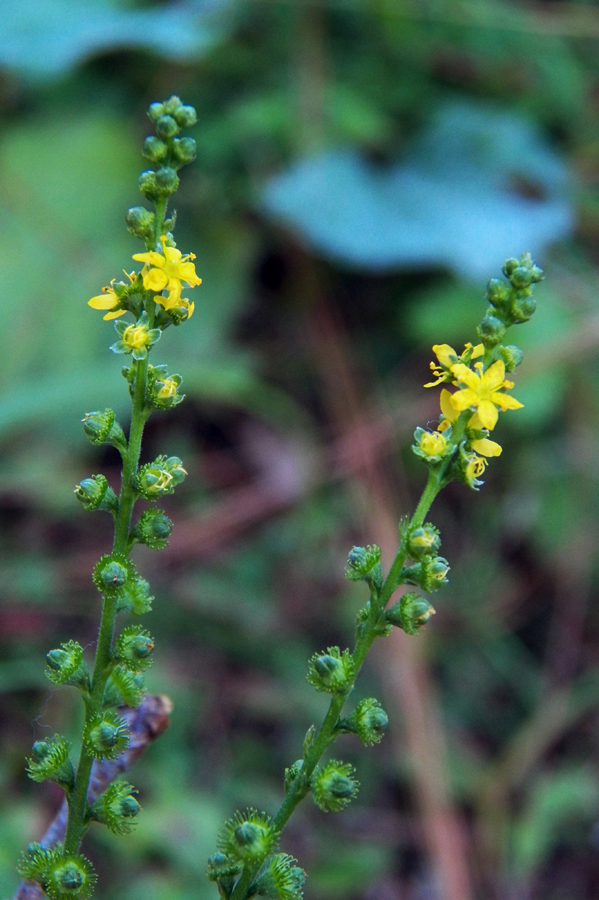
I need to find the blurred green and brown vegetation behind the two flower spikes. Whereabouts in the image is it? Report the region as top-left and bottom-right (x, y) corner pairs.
(0, 0), (599, 900)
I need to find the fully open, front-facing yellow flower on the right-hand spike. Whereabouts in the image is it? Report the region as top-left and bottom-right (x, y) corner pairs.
(451, 359), (522, 431)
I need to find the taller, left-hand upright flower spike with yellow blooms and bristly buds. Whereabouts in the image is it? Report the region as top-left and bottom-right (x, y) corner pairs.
(19, 97), (200, 900)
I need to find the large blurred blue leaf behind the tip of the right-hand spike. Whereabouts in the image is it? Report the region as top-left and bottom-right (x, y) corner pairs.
(262, 103), (572, 279)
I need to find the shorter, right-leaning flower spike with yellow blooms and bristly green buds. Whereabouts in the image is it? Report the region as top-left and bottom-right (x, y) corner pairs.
(208, 253), (543, 900)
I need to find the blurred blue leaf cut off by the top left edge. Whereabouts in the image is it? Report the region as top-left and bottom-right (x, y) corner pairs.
(0, 0), (228, 77)
